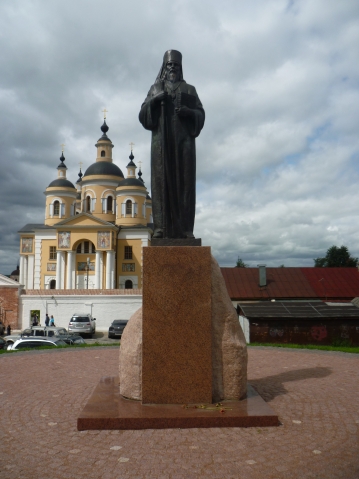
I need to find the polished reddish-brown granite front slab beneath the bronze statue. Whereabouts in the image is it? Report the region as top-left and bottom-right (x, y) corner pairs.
(142, 246), (212, 404)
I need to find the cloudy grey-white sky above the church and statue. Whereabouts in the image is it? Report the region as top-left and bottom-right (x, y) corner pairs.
(0, 0), (359, 274)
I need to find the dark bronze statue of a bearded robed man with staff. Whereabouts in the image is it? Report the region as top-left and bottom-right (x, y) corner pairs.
(139, 50), (205, 238)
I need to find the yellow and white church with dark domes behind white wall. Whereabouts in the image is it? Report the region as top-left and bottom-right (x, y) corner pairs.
(19, 120), (153, 290)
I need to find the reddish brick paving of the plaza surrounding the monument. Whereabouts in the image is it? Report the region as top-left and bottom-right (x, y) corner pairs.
(0, 347), (359, 479)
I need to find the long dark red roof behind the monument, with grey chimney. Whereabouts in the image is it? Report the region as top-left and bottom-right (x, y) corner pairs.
(221, 268), (359, 301)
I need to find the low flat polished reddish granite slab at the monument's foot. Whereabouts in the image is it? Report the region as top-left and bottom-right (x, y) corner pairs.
(77, 377), (279, 431)
